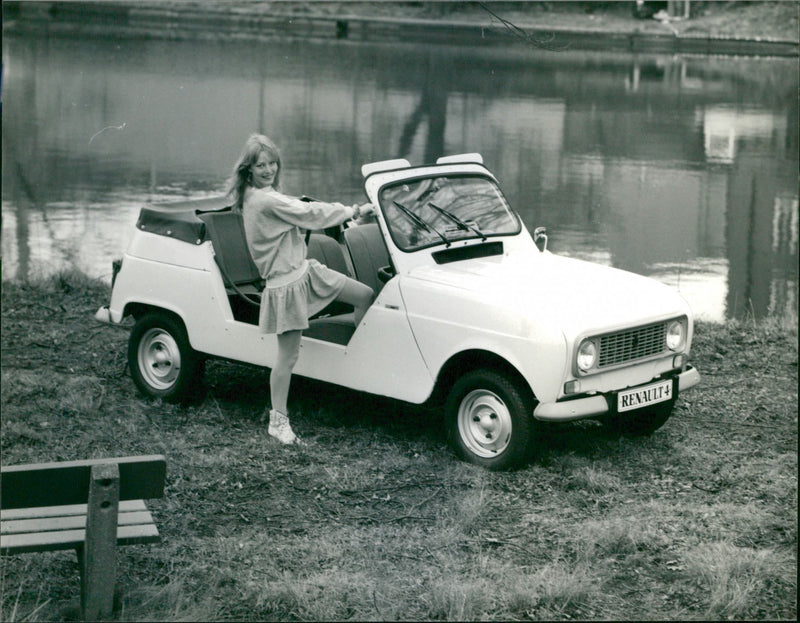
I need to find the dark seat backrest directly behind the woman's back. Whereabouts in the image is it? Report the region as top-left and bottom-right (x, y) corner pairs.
(198, 211), (261, 286)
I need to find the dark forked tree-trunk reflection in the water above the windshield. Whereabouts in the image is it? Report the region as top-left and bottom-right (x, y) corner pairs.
(397, 54), (453, 162)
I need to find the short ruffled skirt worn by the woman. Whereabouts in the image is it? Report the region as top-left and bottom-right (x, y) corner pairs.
(258, 259), (347, 333)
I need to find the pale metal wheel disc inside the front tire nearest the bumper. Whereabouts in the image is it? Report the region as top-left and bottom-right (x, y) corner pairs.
(458, 389), (512, 458)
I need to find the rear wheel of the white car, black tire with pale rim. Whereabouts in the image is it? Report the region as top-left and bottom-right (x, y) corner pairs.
(128, 312), (204, 402)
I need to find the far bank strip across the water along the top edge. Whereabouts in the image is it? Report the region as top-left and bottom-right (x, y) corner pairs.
(3, 0), (800, 56)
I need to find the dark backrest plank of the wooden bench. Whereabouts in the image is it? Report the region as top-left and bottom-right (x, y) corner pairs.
(0, 455), (167, 510)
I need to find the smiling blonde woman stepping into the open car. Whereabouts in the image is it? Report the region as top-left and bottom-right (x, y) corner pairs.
(229, 134), (375, 444)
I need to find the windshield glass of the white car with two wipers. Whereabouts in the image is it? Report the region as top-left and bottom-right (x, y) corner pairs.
(379, 175), (520, 251)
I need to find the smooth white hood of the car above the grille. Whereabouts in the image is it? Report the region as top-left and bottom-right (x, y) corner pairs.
(409, 251), (688, 337)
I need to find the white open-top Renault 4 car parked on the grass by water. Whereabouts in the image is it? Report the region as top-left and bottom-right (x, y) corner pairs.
(96, 154), (700, 469)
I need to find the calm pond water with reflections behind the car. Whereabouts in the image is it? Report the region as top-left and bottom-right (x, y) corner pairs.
(2, 29), (798, 321)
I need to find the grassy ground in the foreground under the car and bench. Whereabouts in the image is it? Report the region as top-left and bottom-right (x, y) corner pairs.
(0, 274), (797, 621)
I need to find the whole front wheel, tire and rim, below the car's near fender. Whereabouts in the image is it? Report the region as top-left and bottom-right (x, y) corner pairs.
(445, 369), (535, 470)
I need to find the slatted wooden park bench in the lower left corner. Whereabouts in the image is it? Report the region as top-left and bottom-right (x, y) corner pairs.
(0, 455), (166, 620)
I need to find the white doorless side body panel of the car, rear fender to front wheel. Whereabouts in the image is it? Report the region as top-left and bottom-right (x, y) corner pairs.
(110, 233), (433, 403)
